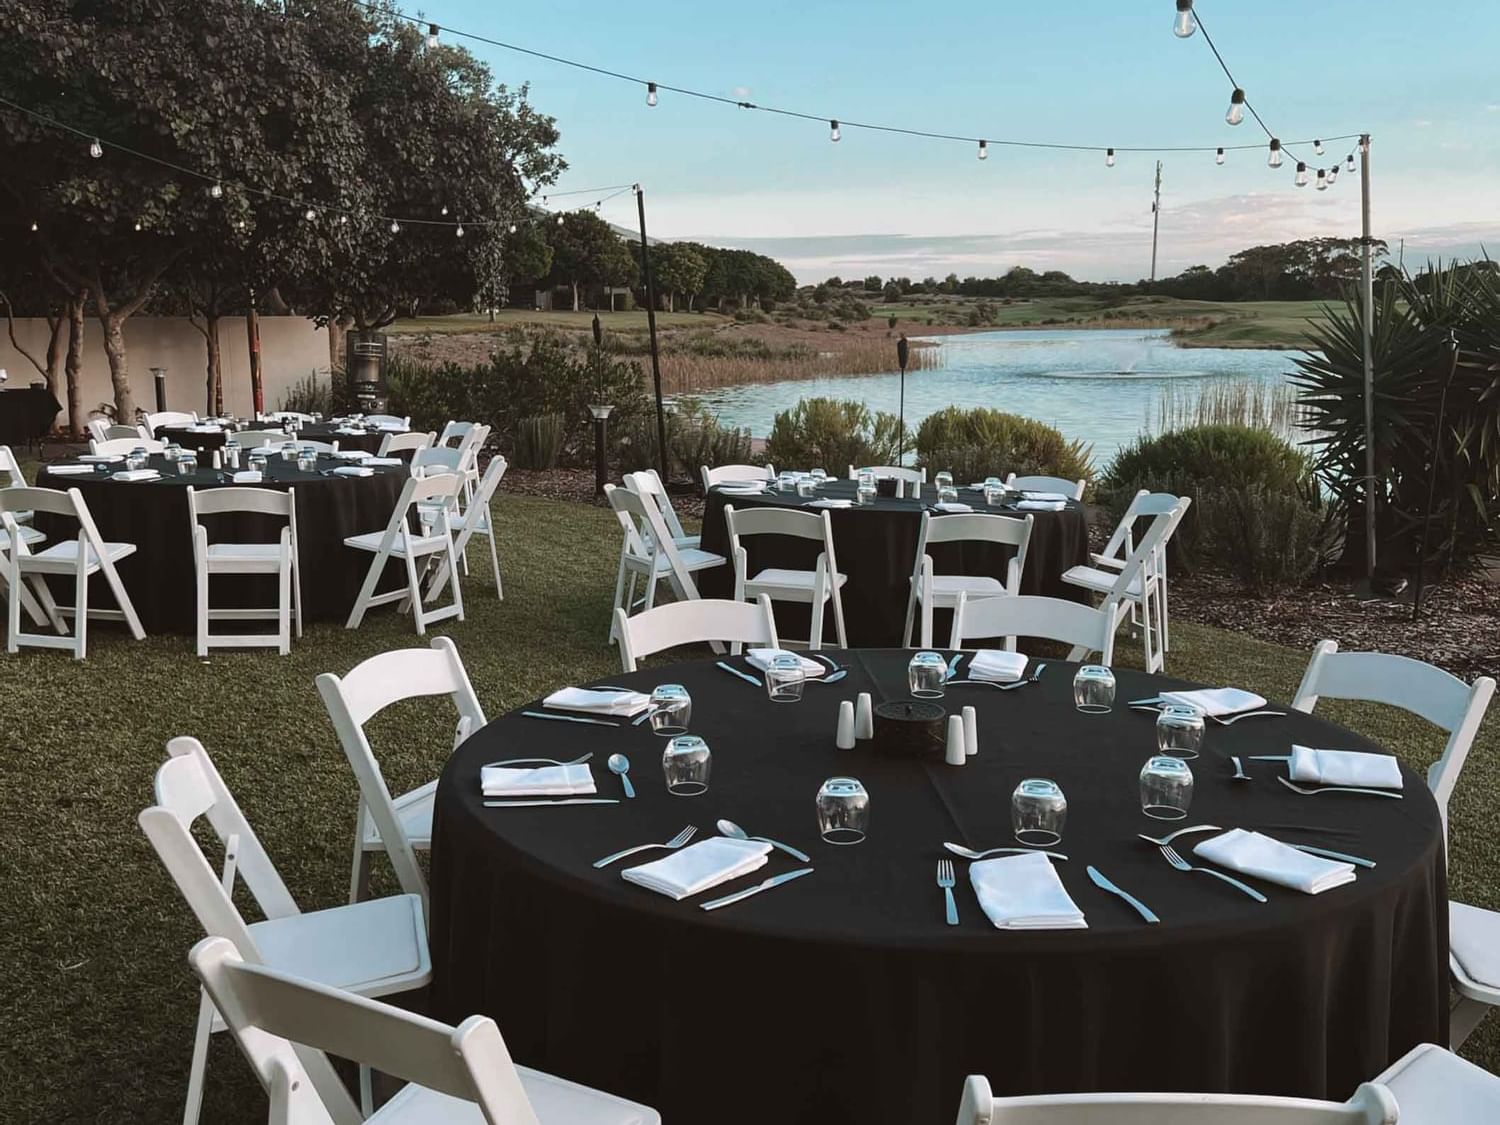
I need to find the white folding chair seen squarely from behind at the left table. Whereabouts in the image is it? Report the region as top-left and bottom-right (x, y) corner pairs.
(188, 486), (302, 656)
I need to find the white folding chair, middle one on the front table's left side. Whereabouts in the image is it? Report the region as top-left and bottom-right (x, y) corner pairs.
(138, 738), (432, 1125)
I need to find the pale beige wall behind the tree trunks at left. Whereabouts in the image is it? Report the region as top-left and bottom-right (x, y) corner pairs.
(0, 317), (329, 428)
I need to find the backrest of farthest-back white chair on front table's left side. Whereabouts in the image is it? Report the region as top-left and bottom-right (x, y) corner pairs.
(317, 639), (485, 902)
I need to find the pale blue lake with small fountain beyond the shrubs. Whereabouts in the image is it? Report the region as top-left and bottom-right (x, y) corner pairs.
(699, 329), (1299, 468)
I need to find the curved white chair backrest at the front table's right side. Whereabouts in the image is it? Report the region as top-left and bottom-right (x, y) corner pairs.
(1292, 641), (1496, 825)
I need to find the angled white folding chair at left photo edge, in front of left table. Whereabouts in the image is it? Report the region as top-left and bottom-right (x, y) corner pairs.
(0, 489), (146, 660)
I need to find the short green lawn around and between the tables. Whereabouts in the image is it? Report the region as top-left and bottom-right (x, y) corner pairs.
(0, 497), (1500, 1124)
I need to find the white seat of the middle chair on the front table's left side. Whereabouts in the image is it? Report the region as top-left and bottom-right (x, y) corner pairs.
(249, 894), (432, 996)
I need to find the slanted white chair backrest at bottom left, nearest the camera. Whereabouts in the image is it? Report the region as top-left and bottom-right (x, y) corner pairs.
(189, 939), (539, 1125)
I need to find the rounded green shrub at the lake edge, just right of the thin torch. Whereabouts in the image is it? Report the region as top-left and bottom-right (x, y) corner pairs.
(917, 407), (1094, 492)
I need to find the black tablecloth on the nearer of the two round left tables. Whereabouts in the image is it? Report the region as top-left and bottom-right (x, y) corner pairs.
(36, 456), (410, 633)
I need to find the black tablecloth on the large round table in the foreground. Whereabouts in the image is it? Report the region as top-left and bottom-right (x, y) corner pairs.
(432, 651), (1448, 1125)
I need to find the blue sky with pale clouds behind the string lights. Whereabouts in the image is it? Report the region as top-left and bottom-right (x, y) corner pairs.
(435, 0), (1500, 284)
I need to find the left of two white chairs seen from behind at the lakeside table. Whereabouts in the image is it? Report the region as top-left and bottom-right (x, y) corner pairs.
(725, 504), (849, 650)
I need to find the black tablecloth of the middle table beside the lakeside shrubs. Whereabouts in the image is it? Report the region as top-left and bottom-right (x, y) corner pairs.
(696, 480), (1089, 647)
